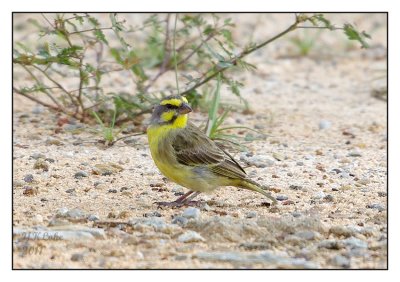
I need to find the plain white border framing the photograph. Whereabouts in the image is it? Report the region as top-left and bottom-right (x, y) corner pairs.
(0, 0), (400, 282)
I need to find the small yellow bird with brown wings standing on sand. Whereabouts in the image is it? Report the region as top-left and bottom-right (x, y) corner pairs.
(147, 95), (276, 207)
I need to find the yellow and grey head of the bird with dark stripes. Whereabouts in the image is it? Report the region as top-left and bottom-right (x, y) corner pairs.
(151, 95), (192, 128)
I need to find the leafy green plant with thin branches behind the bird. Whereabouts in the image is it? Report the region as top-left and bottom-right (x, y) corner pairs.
(13, 13), (369, 143)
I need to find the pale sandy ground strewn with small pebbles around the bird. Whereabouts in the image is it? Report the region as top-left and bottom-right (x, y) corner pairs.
(13, 14), (387, 269)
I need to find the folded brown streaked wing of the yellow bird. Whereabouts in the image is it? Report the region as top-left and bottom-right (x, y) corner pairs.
(172, 123), (247, 179)
